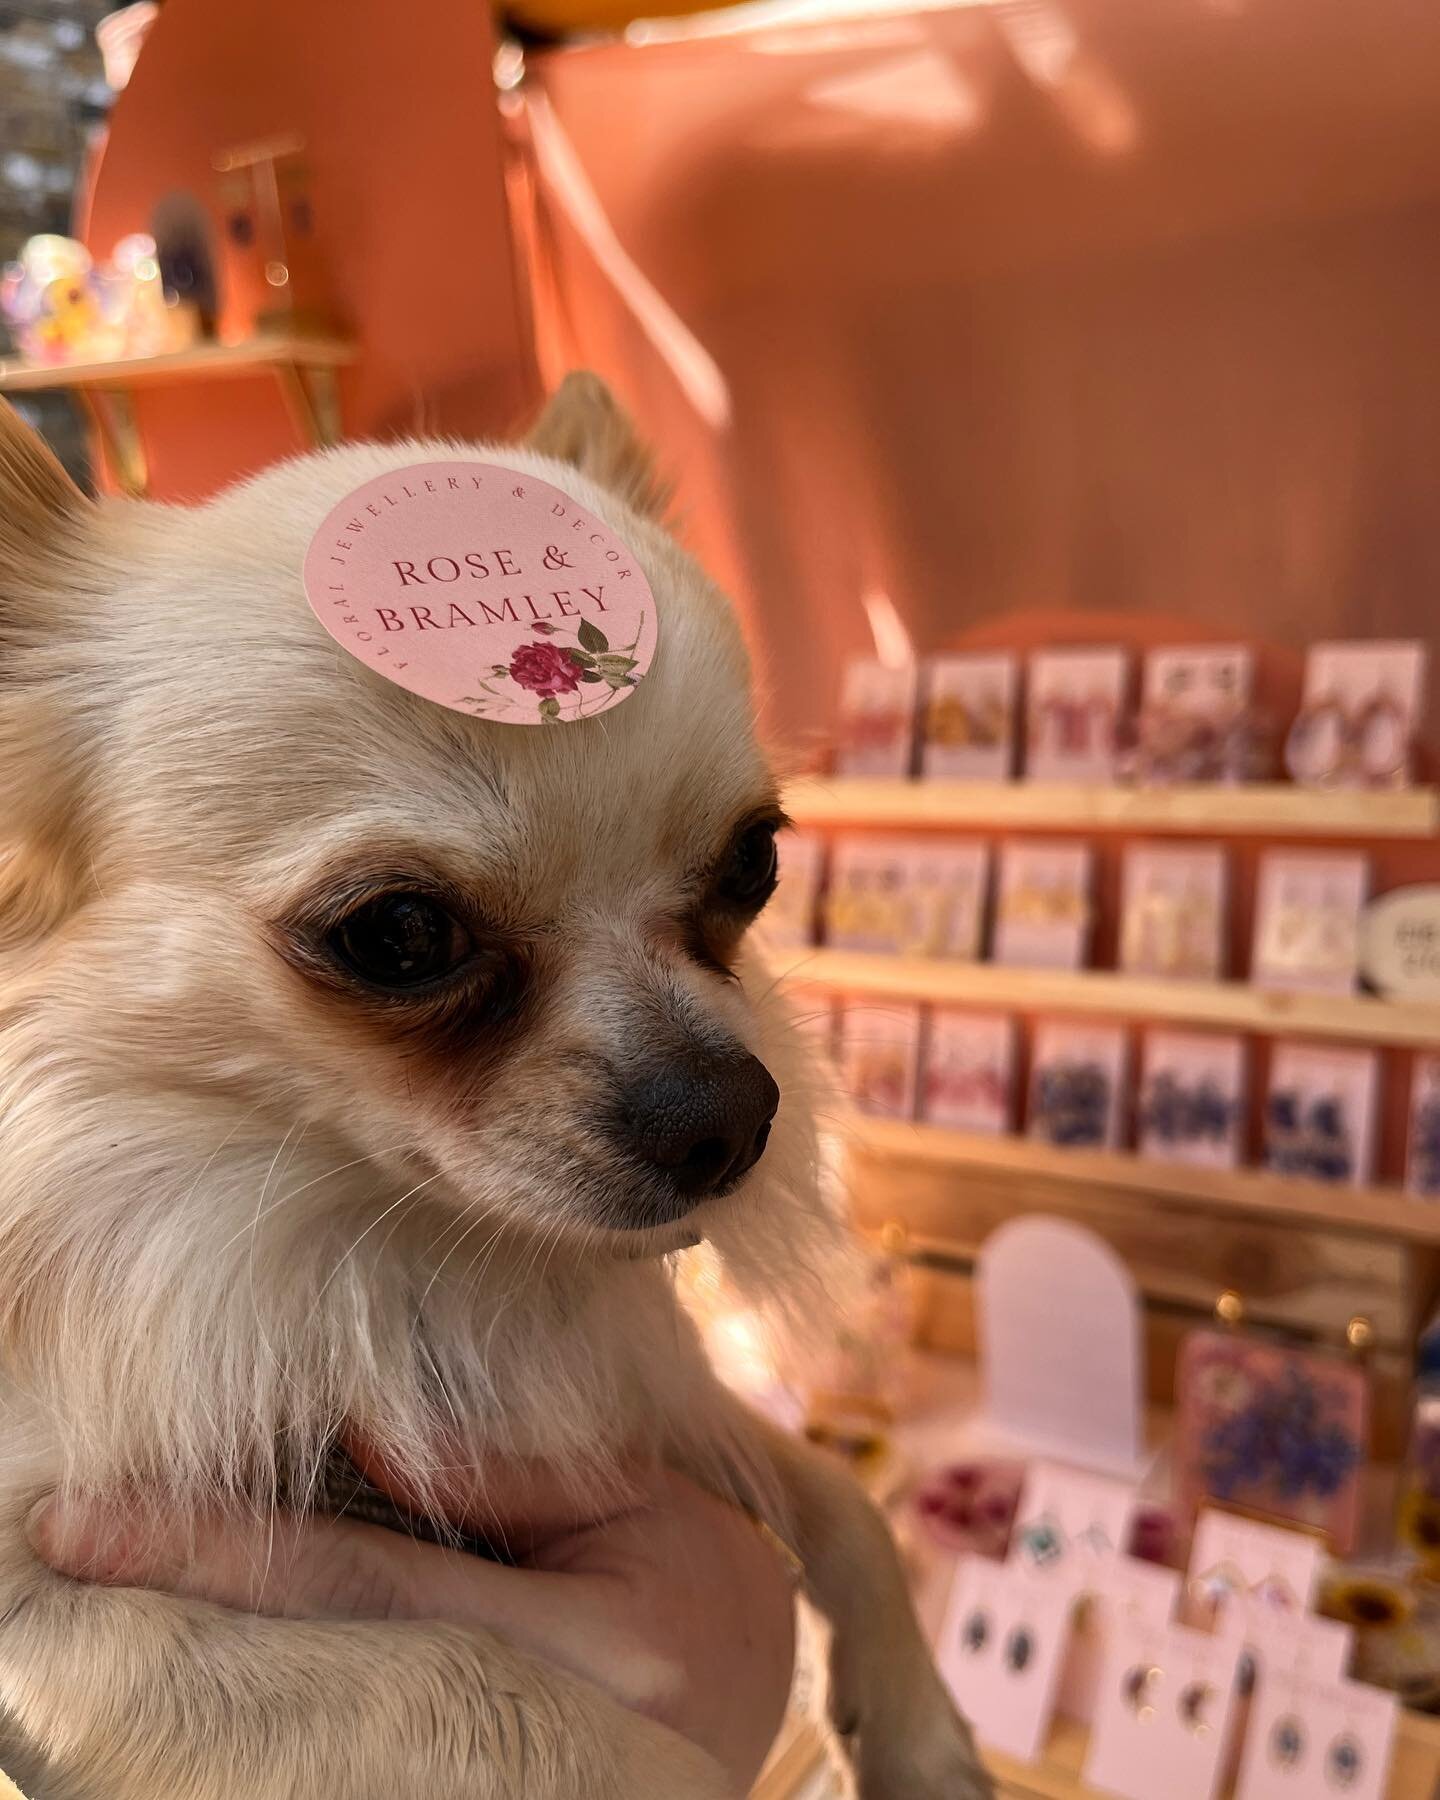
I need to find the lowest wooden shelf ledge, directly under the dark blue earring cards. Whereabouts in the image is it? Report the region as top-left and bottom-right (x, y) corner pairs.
(842, 1114), (1440, 1244)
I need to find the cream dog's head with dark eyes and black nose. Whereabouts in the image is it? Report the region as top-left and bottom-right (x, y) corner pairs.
(0, 378), (828, 1490)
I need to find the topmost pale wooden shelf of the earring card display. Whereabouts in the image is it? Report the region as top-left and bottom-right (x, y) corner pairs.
(785, 776), (1440, 837)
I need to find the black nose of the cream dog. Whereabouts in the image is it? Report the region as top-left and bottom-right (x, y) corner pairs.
(619, 1051), (779, 1201)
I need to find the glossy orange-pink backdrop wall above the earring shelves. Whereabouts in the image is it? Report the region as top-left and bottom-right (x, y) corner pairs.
(517, 0), (1440, 738)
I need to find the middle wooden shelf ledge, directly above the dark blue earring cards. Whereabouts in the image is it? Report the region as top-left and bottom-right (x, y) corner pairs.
(785, 950), (1440, 1048)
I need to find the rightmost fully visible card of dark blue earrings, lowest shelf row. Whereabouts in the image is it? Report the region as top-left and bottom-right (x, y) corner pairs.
(1265, 1044), (1381, 1188)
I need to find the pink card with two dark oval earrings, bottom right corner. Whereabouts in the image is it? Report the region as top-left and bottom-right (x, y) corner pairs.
(1235, 1667), (1396, 1800)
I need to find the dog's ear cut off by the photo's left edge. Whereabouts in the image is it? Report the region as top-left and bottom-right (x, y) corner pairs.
(0, 401), (92, 640)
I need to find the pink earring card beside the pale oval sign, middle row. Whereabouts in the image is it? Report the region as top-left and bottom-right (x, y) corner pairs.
(1251, 851), (1370, 994)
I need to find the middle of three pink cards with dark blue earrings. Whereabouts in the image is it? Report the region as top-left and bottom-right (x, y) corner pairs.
(1136, 1031), (1246, 1168)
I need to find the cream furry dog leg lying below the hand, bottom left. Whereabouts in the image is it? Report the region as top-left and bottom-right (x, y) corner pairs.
(0, 1568), (736, 1800)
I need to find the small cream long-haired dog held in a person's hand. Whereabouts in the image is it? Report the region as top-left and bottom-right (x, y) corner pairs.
(0, 378), (988, 1800)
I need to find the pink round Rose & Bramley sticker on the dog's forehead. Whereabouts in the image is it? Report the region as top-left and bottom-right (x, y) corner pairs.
(304, 463), (659, 725)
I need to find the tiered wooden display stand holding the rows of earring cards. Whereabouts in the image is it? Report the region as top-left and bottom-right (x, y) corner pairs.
(785, 778), (1440, 1458)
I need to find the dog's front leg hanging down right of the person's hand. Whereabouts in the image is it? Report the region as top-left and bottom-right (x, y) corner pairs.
(720, 1413), (992, 1800)
